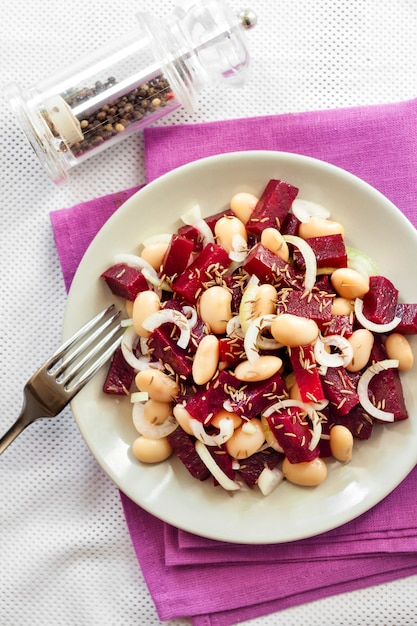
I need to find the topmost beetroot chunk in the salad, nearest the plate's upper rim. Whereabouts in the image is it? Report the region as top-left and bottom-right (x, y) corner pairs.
(246, 179), (298, 237)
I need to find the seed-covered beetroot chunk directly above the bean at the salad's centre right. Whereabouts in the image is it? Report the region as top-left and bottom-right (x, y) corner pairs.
(277, 289), (333, 330)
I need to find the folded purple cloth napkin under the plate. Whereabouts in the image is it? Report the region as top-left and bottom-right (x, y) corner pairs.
(51, 100), (417, 626)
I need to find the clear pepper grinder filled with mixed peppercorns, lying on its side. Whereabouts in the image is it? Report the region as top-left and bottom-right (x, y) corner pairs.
(6, 0), (256, 184)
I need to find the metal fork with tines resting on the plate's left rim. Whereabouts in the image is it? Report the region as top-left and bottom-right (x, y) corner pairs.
(0, 304), (123, 454)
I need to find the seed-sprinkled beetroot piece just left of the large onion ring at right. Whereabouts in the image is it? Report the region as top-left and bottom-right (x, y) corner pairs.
(321, 367), (360, 416)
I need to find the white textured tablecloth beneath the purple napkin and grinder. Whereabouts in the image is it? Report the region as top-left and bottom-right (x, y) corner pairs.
(0, 0), (417, 626)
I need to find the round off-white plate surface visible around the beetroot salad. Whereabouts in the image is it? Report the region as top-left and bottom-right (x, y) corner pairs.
(64, 151), (417, 544)
